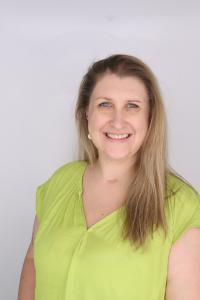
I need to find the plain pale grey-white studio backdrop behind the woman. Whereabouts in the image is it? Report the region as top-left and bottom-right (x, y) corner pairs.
(0, 0), (200, 300)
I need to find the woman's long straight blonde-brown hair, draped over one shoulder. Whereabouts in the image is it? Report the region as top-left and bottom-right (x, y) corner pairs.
(75, 54), (168, 248)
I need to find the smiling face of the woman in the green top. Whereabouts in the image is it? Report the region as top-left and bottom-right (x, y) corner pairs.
(86, 73), (149, 161)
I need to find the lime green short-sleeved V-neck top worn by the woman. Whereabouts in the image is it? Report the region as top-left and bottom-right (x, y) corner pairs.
(34, 161), (200, 300)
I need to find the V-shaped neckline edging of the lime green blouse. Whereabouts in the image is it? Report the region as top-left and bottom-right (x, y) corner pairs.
(78, 161), (125, 232)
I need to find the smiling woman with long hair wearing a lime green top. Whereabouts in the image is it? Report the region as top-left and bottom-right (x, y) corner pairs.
(19, 55), (200, 300)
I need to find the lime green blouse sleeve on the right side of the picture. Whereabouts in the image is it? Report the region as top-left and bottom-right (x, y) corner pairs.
(172, 185), (200, 243)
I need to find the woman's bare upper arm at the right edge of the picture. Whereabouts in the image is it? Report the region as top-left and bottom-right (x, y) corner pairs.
(166, 228), (200, 300)
